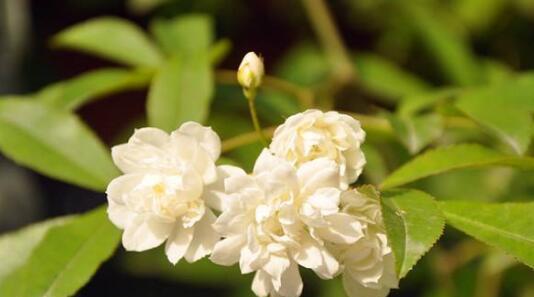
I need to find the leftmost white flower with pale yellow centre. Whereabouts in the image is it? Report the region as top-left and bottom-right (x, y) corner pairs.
(106, 122), (221, 263)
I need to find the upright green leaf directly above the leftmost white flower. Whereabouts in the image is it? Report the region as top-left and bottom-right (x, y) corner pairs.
(147, 52), (214, 131)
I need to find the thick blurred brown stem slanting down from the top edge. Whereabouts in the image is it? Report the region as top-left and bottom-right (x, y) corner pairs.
(302, 0), (356, 84)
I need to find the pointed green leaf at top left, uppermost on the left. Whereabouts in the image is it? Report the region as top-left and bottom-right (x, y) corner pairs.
(52, 17), (162, 67)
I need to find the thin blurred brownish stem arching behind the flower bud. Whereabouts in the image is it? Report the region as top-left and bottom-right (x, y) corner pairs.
(215, 70), (314, 109)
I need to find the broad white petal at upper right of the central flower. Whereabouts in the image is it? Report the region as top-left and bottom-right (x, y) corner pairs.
(297, 158), (339, 193)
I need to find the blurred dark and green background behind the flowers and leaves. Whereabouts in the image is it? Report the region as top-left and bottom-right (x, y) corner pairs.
(0, 0), (534, 297)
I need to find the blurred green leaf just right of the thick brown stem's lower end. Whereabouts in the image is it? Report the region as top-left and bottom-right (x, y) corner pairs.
(355, 53), (430, 101)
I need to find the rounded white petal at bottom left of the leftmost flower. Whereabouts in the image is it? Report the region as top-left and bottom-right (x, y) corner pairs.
(122, 215), (173, 252)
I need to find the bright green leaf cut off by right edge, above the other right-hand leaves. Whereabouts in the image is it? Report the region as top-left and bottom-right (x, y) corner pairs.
(456, 75), (534, 154)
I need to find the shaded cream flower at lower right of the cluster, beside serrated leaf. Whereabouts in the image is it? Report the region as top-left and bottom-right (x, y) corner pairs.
(338, 190), (398, 297)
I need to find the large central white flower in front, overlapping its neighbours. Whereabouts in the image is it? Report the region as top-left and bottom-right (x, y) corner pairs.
(211, 150), (363, 297)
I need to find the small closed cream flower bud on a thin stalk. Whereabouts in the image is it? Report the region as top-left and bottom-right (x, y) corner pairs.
(237, 52), (264, 97)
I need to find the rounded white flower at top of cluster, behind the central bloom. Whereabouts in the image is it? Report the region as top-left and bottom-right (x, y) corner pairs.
(270, 109), (365, 189)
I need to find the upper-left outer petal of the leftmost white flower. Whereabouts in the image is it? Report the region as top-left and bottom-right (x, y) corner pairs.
(111, 128), (169, 173)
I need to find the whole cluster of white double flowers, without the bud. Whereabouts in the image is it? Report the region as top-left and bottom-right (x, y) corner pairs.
(107, 110), (397, 297)
